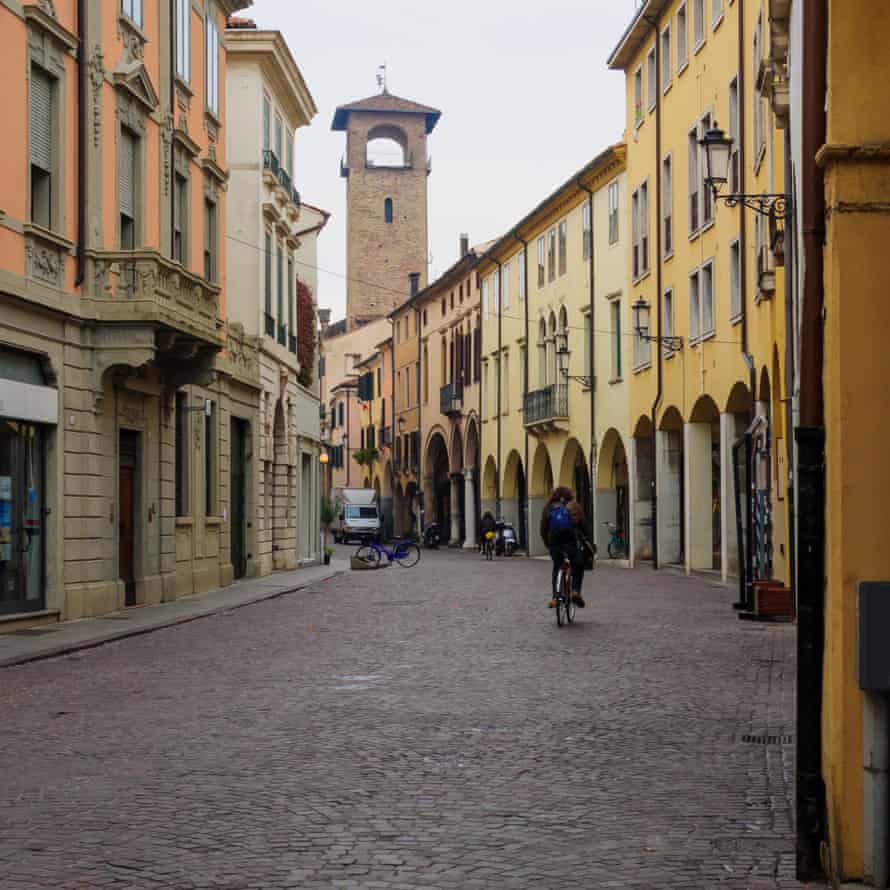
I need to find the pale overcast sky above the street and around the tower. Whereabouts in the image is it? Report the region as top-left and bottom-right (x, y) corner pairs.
(246, 0), (636, 319)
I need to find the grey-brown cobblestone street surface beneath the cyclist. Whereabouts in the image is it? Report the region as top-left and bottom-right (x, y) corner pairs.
(0, 552), (824, 890)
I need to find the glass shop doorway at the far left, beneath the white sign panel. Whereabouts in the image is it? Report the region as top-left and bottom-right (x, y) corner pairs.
(0, 420), (44, 615)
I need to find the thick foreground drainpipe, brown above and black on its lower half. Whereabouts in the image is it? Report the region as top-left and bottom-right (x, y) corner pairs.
(795, 0), (828, 879)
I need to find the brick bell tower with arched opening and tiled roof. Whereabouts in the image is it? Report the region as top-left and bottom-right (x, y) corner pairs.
(331, 87), (441, 330)
